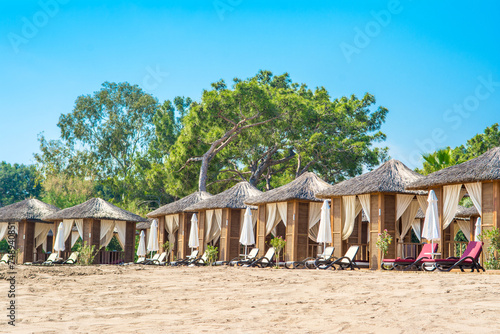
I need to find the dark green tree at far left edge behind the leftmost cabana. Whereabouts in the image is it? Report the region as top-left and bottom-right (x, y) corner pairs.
(0, 161), (42, 207)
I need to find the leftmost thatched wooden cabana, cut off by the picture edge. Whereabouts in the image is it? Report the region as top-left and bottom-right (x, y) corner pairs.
(0, 198), (59, 263)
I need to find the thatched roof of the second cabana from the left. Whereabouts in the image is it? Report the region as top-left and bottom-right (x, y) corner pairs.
(44, 198), (147, 222)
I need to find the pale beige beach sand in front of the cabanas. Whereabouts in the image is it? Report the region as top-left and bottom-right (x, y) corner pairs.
(0, 265), (500, 333)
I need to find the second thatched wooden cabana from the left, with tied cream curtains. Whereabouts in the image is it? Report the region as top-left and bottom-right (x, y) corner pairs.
(44, 198), (147, 263)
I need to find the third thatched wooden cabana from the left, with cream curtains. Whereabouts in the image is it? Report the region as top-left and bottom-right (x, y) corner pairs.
(147, 191), (212, 261)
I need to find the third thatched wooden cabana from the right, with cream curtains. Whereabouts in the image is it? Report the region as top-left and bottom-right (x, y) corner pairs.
(245, 172), (330, 261)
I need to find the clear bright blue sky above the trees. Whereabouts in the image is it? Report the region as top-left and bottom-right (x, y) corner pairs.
(0, 0), (500, 167)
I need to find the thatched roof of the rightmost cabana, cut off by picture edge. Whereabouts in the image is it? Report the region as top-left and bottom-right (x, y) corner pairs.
(406, 147), (500, 189)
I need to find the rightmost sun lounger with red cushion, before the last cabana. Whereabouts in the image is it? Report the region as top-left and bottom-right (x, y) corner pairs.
(421, 241), (485, 272)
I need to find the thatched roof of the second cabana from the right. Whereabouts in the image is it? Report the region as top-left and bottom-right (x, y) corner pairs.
(316, 159), (425, 198)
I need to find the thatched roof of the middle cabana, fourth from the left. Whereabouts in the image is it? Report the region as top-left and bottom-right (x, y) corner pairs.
(184, 181), (262, 212)
